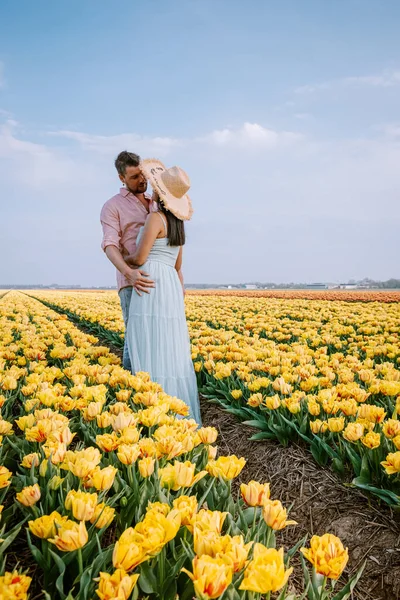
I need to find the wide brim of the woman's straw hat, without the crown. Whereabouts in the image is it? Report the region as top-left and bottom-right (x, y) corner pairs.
(140, 158), (193, 221)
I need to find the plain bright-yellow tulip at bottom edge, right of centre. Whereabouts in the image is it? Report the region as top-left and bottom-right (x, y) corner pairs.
(239, 544), (293, 594)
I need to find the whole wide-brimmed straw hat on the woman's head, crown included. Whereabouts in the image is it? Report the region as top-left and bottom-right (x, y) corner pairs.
(140, 158), (193, 221)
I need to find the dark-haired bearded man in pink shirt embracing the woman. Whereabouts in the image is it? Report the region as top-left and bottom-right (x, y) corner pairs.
(100, 151), (158, 371)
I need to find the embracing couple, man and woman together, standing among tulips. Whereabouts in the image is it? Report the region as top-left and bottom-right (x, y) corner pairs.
(100, 151), (201, 424)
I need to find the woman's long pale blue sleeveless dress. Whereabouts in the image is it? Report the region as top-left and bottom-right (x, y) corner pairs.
(126, 215), (201, 424)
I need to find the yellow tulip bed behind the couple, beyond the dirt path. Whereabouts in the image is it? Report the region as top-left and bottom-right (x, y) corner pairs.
(29, 292), (400, 506)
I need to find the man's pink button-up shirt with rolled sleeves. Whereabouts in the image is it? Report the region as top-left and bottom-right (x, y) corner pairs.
(100, 188), (158, 291)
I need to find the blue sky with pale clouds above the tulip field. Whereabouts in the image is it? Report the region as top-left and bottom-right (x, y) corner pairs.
(0, 0), (400, 286)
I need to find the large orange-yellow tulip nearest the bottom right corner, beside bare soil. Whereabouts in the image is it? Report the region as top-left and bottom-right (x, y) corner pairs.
(300, 533), (349, 579)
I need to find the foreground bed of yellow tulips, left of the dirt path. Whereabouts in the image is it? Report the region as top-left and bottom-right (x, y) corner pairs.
(0, 292), (366, 600)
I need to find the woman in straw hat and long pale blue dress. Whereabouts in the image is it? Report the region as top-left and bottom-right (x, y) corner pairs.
(125, 159), (201, 424)
